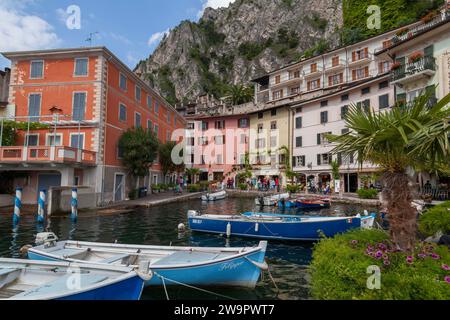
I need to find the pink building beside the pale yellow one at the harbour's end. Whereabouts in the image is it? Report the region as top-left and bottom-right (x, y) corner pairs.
(186, 114), (250, 181)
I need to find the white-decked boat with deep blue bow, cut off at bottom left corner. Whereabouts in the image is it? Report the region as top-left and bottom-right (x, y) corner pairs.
(0, 259), (149, 300)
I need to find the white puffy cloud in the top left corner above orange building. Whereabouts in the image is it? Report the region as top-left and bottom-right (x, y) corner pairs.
(0, 0), (61, 51)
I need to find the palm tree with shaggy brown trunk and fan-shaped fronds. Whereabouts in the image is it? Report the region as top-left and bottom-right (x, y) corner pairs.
(328, 91), (450, 251)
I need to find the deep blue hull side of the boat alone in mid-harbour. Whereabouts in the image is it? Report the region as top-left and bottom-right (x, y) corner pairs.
(189, 216), (361, 241)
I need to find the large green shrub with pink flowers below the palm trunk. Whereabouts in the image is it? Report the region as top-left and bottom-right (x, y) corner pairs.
(310, 230), (450, 300)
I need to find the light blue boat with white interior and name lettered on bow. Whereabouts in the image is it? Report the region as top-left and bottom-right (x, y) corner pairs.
(28, 234), (267, 288)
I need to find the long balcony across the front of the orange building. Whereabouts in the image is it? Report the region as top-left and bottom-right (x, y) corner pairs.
(0, 146), (97, 166)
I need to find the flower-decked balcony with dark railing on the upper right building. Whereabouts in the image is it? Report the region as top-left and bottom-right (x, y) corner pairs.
(391, 57), (436, 85)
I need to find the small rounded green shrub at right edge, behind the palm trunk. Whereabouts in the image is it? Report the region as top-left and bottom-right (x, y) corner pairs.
(419, 201), (450, 236)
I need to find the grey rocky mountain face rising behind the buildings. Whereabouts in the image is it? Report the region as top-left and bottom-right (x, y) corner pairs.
(136, 0), (343, 104)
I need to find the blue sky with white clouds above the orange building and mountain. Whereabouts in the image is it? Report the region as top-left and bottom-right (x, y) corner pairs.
(0, 0), (234, 69)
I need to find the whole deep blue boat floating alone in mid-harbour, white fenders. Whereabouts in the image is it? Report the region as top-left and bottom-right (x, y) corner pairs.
(188, 211), (375, 241)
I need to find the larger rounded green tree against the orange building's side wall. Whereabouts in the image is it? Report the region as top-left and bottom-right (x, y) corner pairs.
(119, 128), (159, 177)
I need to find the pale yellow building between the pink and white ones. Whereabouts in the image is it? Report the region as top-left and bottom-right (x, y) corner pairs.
(249, 104), (293, 185)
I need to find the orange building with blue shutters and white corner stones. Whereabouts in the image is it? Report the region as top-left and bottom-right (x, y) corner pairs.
(0, 47), (185, 205)
